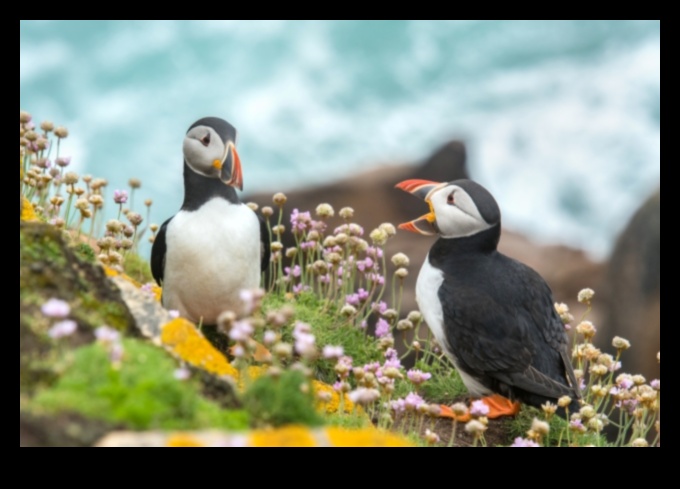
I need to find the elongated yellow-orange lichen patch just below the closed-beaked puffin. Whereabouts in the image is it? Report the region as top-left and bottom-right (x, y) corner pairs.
(161, 318), (238, 378)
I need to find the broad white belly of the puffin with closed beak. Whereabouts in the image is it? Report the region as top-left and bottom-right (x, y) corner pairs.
(163, 199), (261, 324)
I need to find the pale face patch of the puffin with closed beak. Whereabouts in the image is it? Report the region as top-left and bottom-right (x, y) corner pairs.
(182, 126), (227, 178)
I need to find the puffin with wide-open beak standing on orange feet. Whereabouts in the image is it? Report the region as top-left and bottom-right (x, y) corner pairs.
(396, 179), (580, 418)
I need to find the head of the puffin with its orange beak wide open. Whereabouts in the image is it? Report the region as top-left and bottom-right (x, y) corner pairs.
(396, 180), (501, 238)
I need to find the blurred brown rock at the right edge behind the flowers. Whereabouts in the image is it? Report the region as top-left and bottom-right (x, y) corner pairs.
(597, 189), (661, 380)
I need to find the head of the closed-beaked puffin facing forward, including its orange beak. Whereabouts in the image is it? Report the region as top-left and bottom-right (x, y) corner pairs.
(183, 117), (243, 190)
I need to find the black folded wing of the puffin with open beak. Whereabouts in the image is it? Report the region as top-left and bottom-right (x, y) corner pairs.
(439, 254), (576, 398)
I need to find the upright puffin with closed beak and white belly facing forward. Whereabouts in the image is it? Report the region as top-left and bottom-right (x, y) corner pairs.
(151, 117), (270, 325)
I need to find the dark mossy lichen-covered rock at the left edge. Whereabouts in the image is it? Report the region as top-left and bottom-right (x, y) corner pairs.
(19, 222), (136, 395)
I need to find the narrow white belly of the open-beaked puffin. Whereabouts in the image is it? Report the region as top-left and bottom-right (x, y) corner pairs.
(416, 255), (492, 396)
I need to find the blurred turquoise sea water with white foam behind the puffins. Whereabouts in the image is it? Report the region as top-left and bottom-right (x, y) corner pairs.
(20, 21), (661, 256)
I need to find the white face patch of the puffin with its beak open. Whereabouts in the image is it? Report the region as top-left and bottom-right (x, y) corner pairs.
(428, 185), (493, 238)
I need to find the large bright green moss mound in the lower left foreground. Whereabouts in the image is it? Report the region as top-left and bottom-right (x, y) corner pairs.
(30, 339), (247, 429)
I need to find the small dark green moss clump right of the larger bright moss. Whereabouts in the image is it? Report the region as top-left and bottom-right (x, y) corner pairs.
(243, 370), (323, 426)
